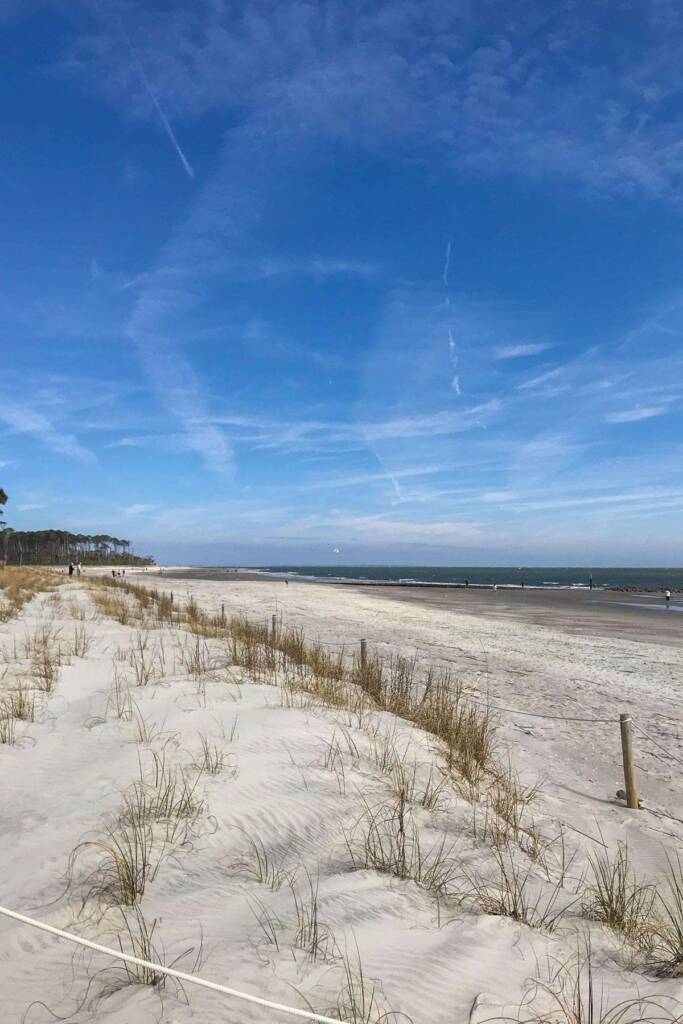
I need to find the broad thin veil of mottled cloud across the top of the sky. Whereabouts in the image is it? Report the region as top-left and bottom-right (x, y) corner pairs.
(71, 0), (683, 198)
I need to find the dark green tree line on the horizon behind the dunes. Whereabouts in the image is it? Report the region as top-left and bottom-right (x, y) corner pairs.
(0, 487), (154, 565)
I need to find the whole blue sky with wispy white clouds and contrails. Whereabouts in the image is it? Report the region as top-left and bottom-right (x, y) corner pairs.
(0, 0), (683, 564)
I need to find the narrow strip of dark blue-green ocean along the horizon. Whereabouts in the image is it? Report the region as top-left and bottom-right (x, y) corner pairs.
(257, 565), (683, 592)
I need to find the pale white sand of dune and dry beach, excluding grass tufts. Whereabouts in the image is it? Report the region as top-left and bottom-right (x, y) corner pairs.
(0, 577), (683, 1024)
